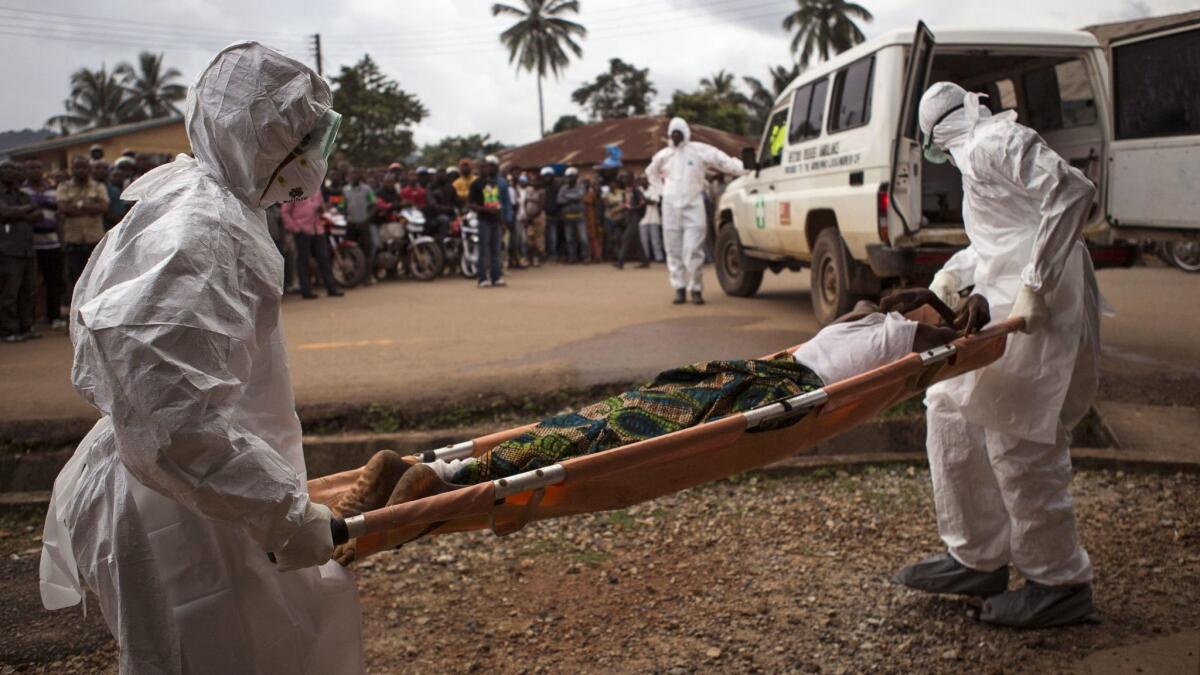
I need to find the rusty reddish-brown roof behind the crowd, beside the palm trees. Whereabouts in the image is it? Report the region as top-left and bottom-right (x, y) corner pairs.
(497, 115), (755, 168)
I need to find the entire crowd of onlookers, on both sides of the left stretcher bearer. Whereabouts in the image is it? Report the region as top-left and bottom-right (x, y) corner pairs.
(0, 147), (720, 342)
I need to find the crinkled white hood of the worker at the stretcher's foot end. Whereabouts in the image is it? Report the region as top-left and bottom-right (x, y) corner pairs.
(177, 42), (332, 208)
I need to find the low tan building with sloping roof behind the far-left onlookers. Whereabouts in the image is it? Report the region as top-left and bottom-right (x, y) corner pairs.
(4, 117), (192, 169)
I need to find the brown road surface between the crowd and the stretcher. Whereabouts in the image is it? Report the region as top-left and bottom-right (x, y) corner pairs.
(0, 265), (1200, 422)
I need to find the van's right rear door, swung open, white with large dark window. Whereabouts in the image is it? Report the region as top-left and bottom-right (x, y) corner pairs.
(1106, 22), (1200, 233)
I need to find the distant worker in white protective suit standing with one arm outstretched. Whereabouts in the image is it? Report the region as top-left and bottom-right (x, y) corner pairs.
(646, 118), (746, 305)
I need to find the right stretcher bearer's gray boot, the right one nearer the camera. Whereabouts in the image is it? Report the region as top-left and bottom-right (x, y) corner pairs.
(979, 581), (1100, 628)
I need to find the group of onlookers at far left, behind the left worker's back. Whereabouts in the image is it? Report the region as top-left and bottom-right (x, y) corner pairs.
(0, 145), (161, 342)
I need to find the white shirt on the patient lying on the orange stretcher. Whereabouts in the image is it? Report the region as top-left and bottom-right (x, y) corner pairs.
(793, 312), (918, 384)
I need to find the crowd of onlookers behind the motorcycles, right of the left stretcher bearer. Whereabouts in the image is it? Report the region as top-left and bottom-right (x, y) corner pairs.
(285, 156), (681, 298)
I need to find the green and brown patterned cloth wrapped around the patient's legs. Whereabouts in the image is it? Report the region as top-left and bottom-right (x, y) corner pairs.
(452, 353), (824, 485)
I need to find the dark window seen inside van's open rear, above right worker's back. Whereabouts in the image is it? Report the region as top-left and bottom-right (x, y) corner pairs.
(1022, 59), (1096, 132)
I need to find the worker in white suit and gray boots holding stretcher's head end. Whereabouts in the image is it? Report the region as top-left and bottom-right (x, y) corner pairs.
(895, 82), (1100, 627)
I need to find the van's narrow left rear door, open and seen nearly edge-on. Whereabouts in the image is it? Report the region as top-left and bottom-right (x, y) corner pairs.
(888, 22), (934, 235)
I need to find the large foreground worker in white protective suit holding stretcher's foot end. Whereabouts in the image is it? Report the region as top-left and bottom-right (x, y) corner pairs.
(40, 42), (362, 674)
